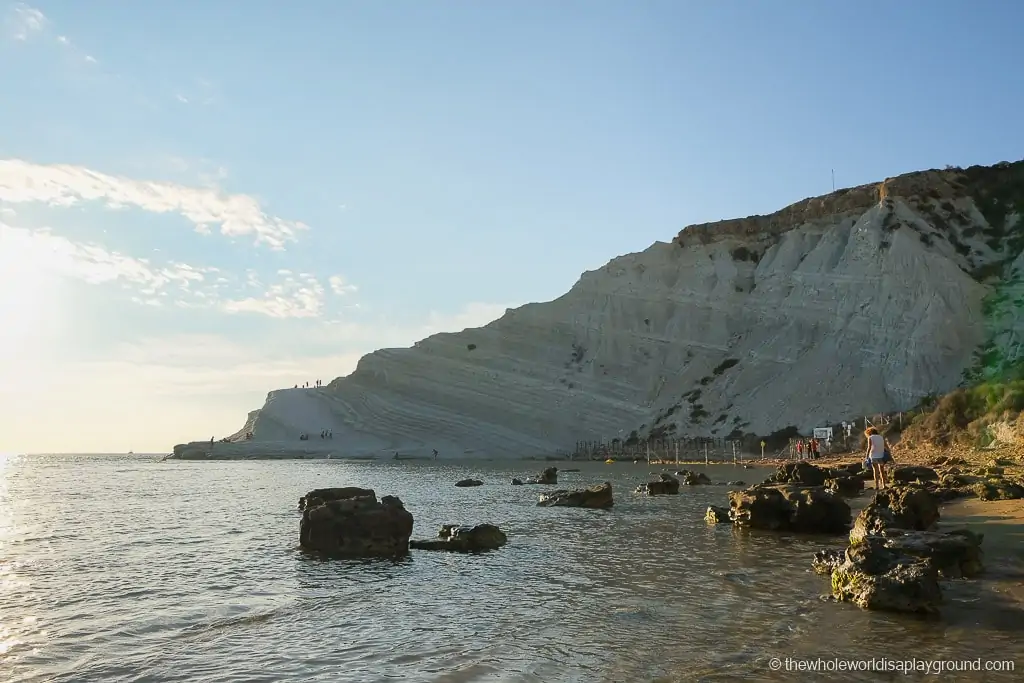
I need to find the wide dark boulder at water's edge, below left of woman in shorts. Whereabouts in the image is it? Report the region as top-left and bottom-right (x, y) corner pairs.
(729, 484), (852, 533)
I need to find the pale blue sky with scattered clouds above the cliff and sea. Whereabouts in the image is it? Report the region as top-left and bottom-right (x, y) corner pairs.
(0, 0), (1024, 453)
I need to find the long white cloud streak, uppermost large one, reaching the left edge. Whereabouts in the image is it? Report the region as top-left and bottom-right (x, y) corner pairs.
(0, 159), (308, 250)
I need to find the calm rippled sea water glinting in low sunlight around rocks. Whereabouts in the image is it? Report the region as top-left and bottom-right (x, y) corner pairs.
(0, 456), (1024, 682)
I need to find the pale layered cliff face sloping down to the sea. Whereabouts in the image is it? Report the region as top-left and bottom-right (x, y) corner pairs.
(232, 162), (1024, 457)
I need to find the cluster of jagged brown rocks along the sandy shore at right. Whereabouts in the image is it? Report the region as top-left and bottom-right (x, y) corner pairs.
(706, 457), (1024, 616)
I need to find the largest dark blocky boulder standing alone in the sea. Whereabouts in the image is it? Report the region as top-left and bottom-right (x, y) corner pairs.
(299, 487), (413, 557)
